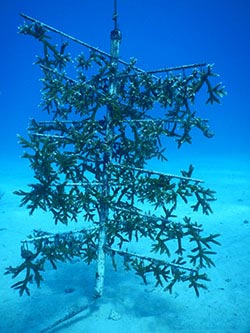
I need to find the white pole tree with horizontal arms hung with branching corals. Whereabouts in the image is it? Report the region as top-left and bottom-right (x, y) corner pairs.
(6, 5), (225, 297)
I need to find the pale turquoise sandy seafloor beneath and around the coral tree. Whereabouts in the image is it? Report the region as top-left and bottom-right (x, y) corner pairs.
(0, 154), (250, 333)
